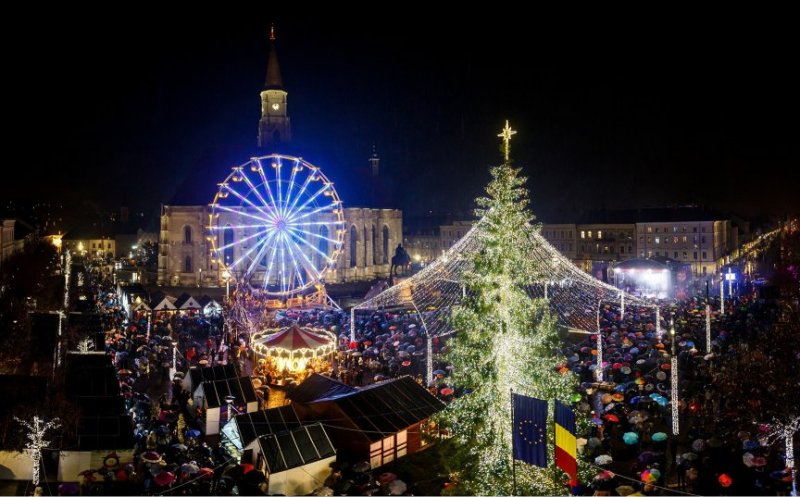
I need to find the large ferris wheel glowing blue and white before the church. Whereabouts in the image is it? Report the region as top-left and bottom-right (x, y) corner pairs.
(208, 154), (345, 298)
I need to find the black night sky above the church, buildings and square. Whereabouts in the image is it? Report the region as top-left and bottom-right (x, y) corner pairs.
(2, 11), (800, 227)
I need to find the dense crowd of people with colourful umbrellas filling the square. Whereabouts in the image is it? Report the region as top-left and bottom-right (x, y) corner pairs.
(70, 250), (800, 495)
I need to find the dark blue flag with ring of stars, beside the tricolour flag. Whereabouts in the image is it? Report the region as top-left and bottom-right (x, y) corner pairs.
(513, 394), (547, 468)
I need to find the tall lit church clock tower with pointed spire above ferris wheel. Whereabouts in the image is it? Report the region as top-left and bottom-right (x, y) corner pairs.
(258, 26), (292, 151)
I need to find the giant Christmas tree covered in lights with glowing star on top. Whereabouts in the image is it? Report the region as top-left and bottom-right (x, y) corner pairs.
(442, 122), (575, 495)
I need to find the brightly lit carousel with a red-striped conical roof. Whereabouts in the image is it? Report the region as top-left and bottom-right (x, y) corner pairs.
(252, 324), (336, 385)
